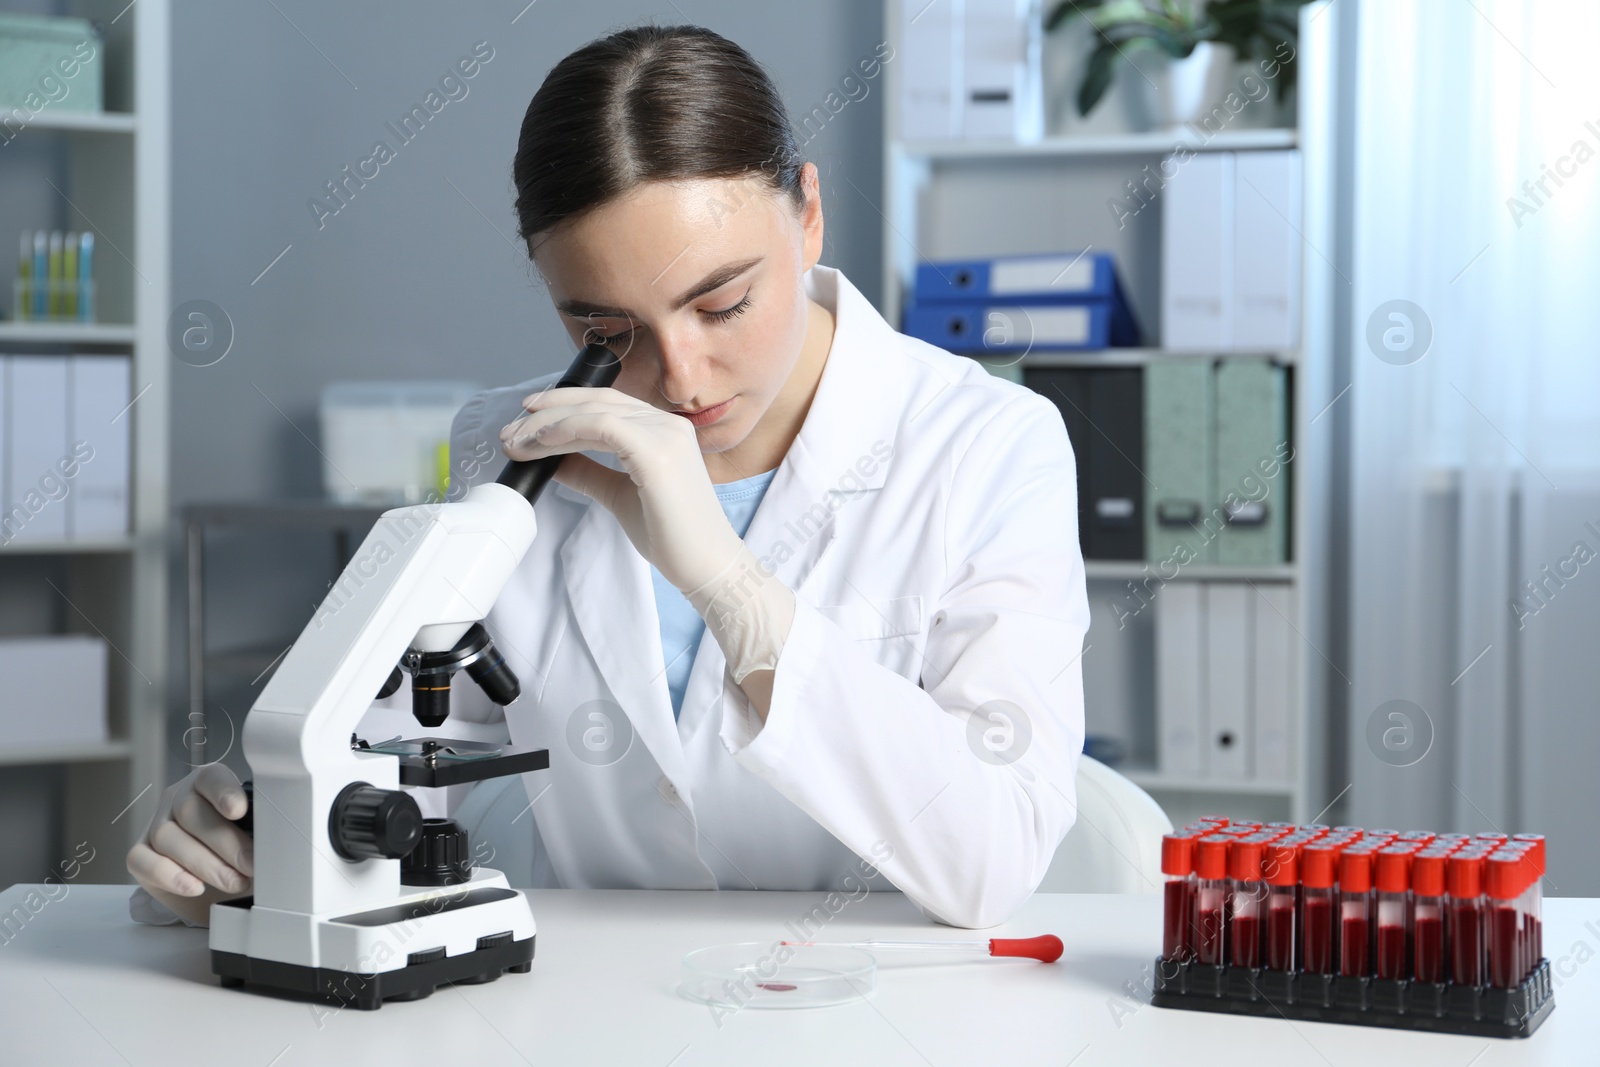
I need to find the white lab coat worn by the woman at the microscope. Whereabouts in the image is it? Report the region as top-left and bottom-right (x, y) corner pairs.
(392, 266), (1090, 928)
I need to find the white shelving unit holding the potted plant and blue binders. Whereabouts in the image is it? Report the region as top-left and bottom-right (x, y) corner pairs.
(880, 0), (1338, 822)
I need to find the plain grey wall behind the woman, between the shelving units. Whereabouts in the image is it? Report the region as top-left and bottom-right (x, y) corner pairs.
(170, 0), (883, 771)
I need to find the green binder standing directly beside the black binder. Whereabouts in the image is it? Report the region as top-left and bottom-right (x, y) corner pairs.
(1144, 357), (1222, 566)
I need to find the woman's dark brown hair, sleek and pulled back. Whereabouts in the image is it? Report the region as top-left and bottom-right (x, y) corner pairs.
(512, 26), (805, 242)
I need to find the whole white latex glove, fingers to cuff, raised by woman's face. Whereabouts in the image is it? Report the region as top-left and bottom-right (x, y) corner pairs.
(501, 387), (794, 683)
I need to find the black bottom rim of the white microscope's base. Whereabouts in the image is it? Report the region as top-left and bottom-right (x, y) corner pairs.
(211, 937), (534, 1011)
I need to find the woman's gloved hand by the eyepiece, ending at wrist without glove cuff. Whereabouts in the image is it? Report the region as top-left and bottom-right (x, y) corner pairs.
(501, 387), (742, 592)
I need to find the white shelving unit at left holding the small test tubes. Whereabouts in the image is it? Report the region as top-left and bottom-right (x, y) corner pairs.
(0, 0), (171, 881)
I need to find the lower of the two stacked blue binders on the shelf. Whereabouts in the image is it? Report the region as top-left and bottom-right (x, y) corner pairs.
(902, 302), (1115, 355)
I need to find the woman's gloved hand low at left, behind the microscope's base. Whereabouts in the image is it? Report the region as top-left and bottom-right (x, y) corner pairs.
(128, 763), (256, 926)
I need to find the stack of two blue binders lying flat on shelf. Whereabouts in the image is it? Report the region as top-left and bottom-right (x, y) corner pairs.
(901, 253), (1139, 355)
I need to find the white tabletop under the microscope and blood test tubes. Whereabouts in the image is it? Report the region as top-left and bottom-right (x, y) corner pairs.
(0, 885), (1600, 1067)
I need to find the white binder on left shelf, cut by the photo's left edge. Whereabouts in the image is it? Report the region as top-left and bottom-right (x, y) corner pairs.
(0, 355), (70, 542)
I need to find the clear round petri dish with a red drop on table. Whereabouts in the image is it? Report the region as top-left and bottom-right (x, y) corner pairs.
(678, 941), (878, 1009)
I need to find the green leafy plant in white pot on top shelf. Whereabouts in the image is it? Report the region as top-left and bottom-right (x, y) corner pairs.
(1045, 0), (1307, 126)
